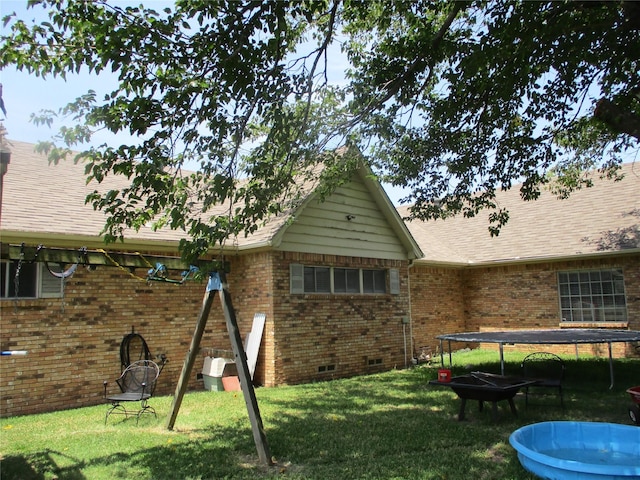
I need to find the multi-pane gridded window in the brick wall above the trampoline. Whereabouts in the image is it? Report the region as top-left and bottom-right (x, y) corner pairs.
(558, 270), (627, 322)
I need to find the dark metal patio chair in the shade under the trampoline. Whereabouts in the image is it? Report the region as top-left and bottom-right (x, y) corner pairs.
(520, 352), (565, 408)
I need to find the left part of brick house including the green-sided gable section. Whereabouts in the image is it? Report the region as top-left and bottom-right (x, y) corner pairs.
(0, 142), (422, 416)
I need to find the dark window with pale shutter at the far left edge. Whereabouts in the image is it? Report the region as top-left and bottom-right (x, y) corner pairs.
(0, 260), (62, 298)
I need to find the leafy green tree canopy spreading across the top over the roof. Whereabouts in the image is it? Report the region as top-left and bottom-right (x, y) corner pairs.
(0, 0), (640, 255)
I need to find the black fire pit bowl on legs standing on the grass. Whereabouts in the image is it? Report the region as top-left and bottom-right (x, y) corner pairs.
(429, 372), (535, 420)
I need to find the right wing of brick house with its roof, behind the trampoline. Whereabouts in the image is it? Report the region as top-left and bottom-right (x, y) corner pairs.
(399, 163), (640, 356)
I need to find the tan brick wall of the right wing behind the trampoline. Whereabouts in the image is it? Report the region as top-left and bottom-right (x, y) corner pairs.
(410, 255), (640, 356)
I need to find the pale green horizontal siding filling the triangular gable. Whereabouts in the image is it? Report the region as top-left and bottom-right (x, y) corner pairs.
(277, 178), (408, 260)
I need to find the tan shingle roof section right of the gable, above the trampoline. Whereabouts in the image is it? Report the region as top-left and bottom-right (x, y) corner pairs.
(399, 163), (640, 264)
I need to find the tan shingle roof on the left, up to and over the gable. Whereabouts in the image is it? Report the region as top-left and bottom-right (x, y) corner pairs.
(0, 141), (421, 256)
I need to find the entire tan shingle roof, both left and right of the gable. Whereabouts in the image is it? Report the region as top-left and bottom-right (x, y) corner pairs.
(5, 141), (640, 265)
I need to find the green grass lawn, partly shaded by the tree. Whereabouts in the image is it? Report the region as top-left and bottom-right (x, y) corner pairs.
(0, 351), (640, 480)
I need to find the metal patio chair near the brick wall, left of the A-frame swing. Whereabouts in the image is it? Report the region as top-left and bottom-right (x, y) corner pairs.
(104, 360), (160, 425)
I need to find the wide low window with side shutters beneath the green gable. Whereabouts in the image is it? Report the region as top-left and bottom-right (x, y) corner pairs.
(290, 264), (400, 295)
